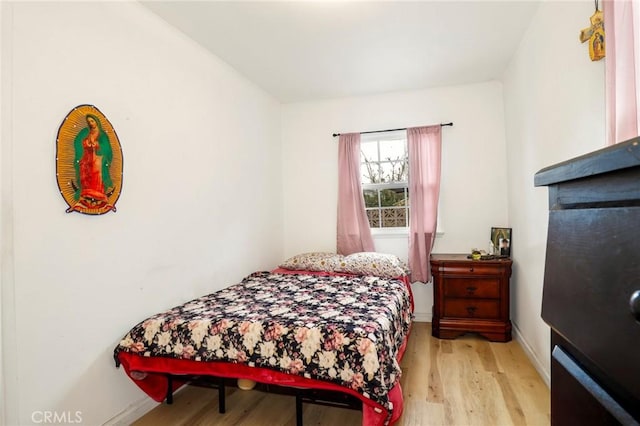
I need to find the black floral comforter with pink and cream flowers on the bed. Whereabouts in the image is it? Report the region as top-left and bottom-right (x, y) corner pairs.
(114, 272), (412, 412)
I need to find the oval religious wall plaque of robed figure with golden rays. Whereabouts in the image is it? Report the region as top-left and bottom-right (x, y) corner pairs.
(56, 105), (122, 215)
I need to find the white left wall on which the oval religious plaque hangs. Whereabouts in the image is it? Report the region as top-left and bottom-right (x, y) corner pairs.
(1, 2), (282, 425)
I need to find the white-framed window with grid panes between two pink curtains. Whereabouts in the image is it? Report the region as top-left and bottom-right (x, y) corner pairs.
(360, 131), (409, 229)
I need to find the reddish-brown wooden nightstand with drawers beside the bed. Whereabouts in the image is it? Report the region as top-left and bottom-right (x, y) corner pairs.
(431, 254), (511, 342)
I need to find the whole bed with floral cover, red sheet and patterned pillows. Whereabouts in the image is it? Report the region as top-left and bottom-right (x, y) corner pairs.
(114, 253), (413, 426)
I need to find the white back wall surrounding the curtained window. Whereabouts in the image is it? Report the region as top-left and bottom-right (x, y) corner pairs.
(282, 82), (508, 321)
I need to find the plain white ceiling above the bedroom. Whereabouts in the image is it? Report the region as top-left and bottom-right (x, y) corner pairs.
(142, 0), (540, 103)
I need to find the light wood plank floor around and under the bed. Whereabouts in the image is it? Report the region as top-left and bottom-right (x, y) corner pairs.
(134, 323), (550, 426)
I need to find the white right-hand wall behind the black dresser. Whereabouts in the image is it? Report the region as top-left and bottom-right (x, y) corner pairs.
(504, 1), (605, 380)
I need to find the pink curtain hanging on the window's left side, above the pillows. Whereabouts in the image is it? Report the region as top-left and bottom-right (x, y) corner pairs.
(337, 133), (375, 255)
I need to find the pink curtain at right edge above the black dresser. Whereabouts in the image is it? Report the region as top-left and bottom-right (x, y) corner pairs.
(604, 0), (640, 145)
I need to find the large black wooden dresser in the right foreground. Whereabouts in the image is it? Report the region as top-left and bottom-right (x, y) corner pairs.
(535, 138), (640, 425)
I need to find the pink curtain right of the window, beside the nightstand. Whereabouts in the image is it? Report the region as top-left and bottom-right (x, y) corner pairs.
(407, 125), (442, 283)
